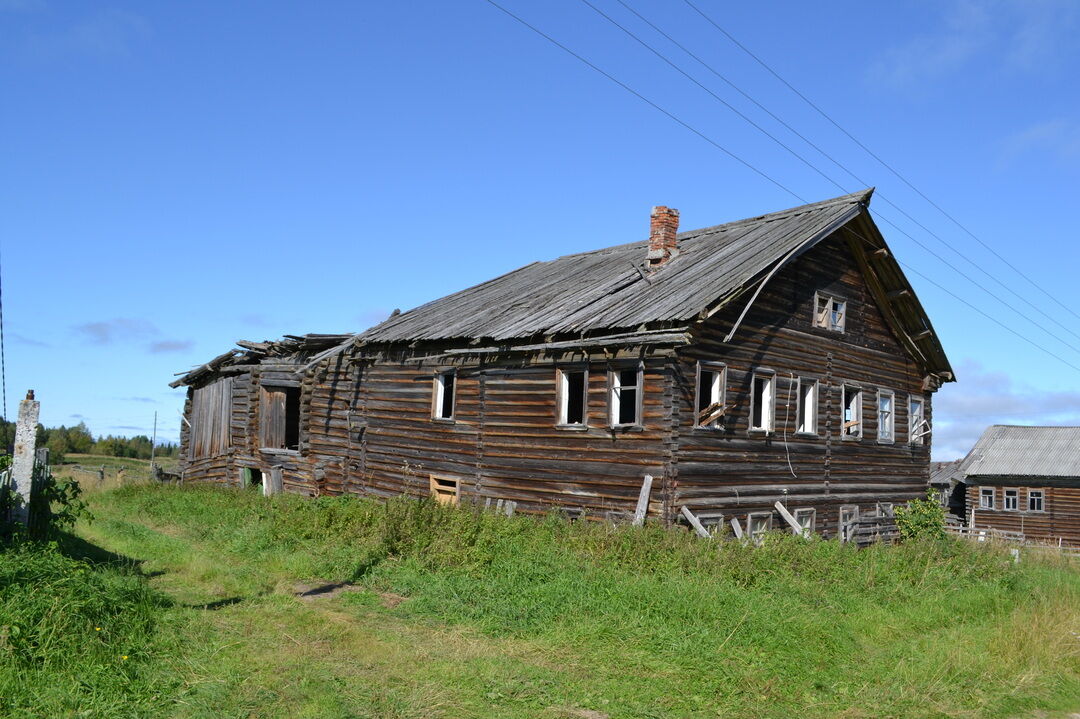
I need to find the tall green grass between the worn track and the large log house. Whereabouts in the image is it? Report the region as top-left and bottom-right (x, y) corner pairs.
(97, 487), (1080, 717)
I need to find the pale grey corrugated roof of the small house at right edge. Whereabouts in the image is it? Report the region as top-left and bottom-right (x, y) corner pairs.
(962, 424), (1080, 477)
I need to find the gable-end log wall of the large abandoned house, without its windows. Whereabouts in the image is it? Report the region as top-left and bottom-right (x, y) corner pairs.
(675, 232), (930, 535)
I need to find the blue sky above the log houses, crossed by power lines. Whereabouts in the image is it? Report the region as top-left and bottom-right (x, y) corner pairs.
(0, 0), (1080, 459)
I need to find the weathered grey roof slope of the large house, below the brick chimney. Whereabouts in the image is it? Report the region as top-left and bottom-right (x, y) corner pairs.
(361, 190), (873, 342)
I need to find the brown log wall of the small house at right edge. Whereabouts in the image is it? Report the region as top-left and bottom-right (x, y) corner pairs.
(966, 480), (1080, 545)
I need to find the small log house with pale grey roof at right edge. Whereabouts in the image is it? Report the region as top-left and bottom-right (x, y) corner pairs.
(960, 424), (1080, 545)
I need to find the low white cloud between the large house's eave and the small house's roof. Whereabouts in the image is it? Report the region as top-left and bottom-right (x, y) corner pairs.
(933, 361), (1080, 460)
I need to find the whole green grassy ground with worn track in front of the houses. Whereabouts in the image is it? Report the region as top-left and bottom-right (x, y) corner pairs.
(0, 486), (1080, 719)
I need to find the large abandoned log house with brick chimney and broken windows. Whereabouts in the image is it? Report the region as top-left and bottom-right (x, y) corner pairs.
(174, 190), (954, 535)
